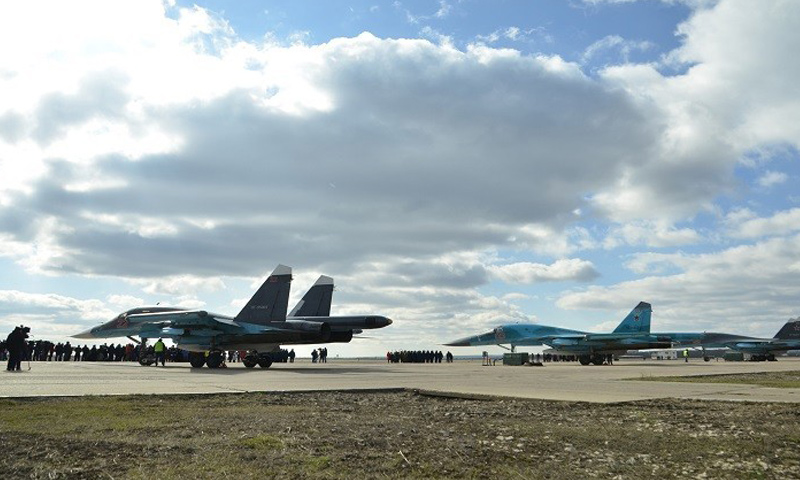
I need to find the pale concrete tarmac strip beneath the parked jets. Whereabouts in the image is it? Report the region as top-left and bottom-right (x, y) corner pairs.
(0, 358), (800, 403)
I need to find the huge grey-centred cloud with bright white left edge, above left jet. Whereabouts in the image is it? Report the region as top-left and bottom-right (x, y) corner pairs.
(0, 3), (654, 277)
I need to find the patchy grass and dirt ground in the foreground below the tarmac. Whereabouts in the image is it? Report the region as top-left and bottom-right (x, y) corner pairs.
(0, 391), (800, 479)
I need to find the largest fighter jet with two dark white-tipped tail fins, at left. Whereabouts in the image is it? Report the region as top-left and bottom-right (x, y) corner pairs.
(74, 265), (392, 368)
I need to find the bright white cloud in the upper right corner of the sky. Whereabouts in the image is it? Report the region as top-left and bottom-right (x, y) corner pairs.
(592, 0), (800, 221)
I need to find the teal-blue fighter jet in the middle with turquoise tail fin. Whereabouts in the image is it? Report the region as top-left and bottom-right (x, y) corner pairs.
(445, 302), (672, 365)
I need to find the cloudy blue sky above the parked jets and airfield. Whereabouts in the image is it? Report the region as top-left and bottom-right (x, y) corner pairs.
(0, 0), (800, 357)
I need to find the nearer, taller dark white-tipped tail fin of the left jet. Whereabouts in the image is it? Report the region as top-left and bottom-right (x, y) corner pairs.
(235, 265), (292, 325)
